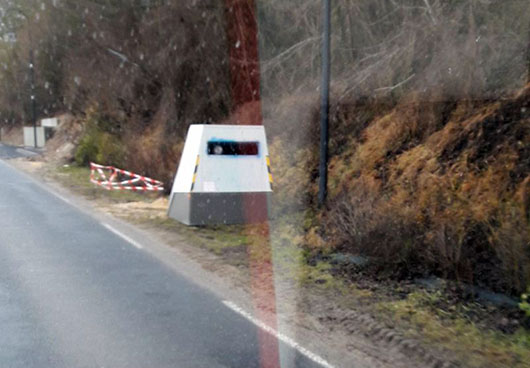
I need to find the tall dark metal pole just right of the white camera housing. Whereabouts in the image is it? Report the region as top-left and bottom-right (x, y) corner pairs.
(318, 0), (331, 206)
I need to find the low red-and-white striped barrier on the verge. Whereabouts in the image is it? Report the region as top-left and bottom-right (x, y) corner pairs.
(90, 162), (164, 192)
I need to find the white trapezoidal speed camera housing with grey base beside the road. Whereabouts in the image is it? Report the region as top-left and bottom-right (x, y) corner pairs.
(168, 124), (272, 225)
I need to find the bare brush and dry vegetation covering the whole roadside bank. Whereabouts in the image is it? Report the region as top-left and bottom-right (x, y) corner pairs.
(0, 0), (530, 294)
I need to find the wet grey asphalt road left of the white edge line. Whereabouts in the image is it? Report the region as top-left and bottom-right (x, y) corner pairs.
(0, 158), (326, 368)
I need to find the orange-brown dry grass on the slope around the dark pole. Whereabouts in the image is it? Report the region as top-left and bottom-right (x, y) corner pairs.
(272, 87), (530, 293)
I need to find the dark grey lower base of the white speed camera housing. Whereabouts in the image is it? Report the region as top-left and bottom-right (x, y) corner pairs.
(168, 192), (272, 225)
